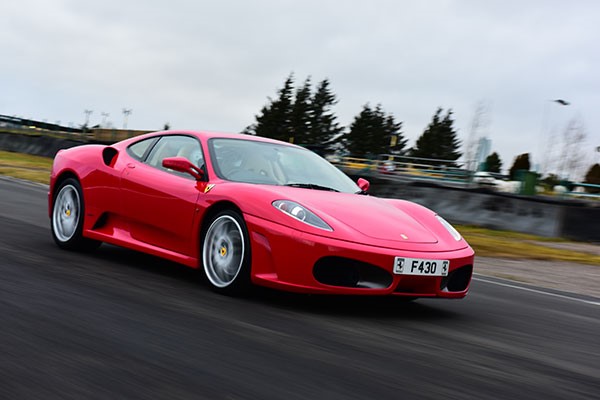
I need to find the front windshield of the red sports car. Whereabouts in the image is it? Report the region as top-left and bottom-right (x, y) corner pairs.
(209, 138), (360, 193)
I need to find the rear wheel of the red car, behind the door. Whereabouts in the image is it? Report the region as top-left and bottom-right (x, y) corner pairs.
(51, 178), (100, 250)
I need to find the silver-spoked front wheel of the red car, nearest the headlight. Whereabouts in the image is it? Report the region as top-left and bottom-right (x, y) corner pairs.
(202, 210), (250, 294)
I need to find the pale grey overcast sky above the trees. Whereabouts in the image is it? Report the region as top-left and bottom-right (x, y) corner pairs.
(0, 0), (600, 175)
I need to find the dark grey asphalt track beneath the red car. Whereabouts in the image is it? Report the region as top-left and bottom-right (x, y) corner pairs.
(0, 179), (600, 400)
